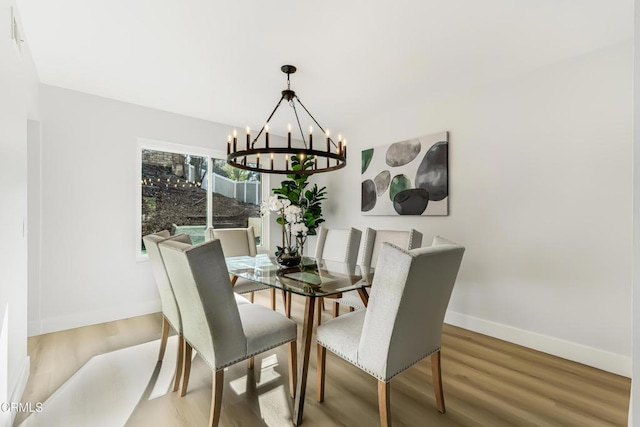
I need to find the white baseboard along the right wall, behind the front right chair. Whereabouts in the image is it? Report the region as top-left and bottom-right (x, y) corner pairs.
(444, 311), (631, 378)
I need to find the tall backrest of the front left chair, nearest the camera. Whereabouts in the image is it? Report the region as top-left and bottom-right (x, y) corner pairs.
(160, 240), (247, 371)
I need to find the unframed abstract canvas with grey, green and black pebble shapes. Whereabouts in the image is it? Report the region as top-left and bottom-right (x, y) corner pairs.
(361, 132), (449, 215)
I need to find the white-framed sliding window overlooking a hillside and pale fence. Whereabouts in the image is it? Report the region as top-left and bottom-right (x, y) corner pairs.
(137, 140), (268, 259)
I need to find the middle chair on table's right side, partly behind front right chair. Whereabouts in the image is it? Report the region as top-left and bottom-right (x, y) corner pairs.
(330, 227), (422, 317)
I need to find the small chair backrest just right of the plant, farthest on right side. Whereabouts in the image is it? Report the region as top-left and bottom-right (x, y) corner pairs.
(315, 227), (362, 271)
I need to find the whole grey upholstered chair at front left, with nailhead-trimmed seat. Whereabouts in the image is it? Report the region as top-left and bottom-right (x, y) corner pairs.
(159, 239), (297, 426)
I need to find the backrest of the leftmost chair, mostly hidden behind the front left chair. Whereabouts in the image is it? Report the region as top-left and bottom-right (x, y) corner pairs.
(142, 230), (191, 333)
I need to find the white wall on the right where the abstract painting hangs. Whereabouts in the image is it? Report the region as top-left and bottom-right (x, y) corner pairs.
(327, 41), (633, 376)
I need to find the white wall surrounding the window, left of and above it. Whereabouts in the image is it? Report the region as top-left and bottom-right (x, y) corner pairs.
(29, 85), (258, 335)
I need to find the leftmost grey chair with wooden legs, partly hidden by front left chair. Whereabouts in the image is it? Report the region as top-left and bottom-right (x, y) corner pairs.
(142, 230), (191, 391)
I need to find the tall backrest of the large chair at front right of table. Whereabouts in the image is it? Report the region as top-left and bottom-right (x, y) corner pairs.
(358, 238), (464, 381)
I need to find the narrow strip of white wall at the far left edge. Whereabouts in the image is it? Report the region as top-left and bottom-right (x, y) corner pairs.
(0, 0), (38, 425)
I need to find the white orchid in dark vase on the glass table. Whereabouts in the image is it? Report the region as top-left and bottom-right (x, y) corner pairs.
(260, 195), (309, 256)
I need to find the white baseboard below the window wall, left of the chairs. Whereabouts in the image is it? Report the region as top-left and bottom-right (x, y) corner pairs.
(34, 299), (161, 336)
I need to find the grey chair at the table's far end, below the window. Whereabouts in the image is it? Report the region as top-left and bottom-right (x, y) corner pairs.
(204, 227), (276, 310)
